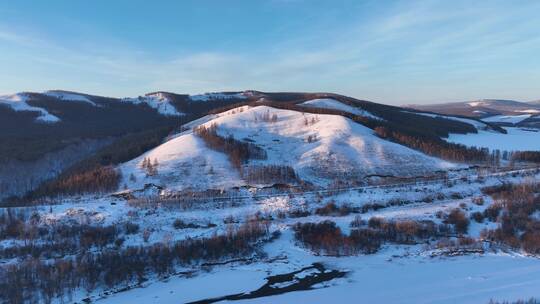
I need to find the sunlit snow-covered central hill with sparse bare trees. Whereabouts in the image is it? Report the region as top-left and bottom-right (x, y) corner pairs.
(121, 106), (455, 190)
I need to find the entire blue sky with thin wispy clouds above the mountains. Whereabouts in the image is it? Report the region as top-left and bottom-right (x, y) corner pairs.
(0, 0), (540, 104)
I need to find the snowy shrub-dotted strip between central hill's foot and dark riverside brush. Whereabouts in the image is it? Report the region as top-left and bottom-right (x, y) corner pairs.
(41, 165), (540, 246)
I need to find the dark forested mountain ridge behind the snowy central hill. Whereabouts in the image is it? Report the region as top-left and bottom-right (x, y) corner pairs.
(0, 90), (505, 199)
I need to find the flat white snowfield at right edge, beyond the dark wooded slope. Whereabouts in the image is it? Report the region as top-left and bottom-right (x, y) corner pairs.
(447, 128), (540, 151)
